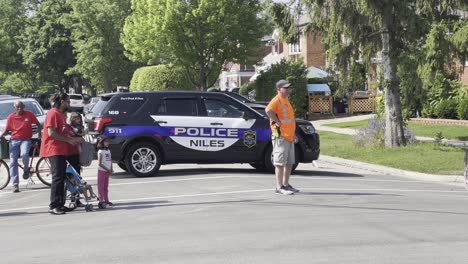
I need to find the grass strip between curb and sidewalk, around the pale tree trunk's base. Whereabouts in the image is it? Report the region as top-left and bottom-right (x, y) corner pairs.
(319, 130), (464, 175)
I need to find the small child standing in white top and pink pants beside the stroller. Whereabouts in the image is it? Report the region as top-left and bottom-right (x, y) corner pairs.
(97, 137), (114, 208)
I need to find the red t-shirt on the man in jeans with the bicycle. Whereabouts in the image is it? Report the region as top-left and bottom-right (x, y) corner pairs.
(5, 110), (39, 139)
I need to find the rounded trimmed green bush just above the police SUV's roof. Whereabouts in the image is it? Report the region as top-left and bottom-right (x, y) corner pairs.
(130, 64), (194, 91)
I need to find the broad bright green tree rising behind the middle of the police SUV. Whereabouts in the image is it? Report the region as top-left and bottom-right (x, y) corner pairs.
(121, 0), (268, 90)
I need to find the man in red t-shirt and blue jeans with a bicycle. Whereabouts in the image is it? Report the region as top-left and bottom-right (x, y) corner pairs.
(0, 101), (40, 192)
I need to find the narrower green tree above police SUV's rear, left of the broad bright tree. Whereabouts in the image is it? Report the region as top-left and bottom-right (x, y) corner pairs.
(66, 0), (137, 93)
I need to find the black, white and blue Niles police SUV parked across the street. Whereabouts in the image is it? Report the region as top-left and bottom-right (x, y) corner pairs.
(86, 91), (320, 177)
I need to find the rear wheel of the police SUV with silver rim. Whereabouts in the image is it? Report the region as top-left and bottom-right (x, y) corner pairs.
(125, 142), (162, 177)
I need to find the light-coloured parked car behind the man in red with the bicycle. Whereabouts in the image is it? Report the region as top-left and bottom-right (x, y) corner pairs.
(0, 96), (46, 139)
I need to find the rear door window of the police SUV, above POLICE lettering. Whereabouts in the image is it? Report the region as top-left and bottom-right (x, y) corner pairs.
(157, 98), (198, 116)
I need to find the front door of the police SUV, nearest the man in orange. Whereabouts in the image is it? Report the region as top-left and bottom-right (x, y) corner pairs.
(200, 94), (257, 162)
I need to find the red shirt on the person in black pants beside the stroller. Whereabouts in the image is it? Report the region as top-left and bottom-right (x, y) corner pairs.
(39, 108), (69, 157)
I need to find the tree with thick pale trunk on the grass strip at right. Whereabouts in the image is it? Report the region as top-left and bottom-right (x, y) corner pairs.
(284, 0), (462, 147)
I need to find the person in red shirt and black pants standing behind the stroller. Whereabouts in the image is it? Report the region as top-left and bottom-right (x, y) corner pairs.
(40, 93), (83, 215)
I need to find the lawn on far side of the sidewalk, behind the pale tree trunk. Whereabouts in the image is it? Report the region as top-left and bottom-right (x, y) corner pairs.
(326, 120), (468, 140)
